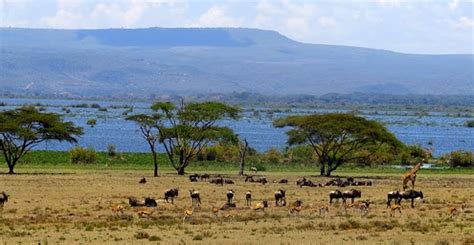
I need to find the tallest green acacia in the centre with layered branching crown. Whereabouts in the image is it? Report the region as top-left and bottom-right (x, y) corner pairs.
(129, 102), (239, 175)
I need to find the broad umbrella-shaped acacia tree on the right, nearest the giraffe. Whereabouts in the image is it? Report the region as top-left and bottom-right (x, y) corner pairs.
(274, 113), (403, 176)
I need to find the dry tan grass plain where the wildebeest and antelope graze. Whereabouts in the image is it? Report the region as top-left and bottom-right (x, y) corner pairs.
(0, 171), (474, 244)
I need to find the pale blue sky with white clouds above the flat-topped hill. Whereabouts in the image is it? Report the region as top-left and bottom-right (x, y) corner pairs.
(0, 0), (474, 54)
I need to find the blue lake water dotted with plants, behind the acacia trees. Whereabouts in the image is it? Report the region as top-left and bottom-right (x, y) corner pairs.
(0, 98), (474, 156)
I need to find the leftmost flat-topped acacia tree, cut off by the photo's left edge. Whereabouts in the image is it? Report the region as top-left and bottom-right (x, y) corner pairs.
(0, 107), (83, 174)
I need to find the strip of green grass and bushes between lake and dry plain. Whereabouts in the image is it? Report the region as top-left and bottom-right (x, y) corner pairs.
(0, 151), (474, 176)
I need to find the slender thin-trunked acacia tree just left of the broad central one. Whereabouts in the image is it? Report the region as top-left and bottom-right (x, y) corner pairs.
(126, 114), (159, 177)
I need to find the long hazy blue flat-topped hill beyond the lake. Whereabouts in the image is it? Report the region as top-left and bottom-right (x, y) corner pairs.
(0, 28), (474, 97)
